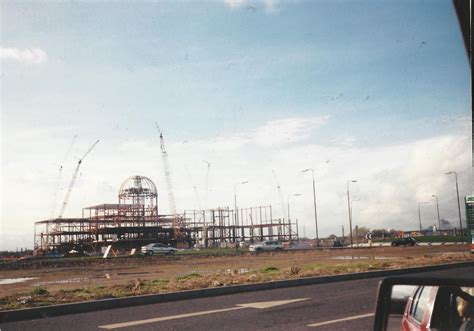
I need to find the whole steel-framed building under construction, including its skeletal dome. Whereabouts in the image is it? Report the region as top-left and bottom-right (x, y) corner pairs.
(35, 176), (298, 253)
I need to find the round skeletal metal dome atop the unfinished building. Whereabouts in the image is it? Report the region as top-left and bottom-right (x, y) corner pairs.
(119, 175), (158, 206)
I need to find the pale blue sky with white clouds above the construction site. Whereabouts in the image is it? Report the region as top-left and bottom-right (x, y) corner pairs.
(0, 0), (472, 250)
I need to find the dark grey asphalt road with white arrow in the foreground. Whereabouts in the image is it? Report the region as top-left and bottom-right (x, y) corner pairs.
(0, 267), (474, 331)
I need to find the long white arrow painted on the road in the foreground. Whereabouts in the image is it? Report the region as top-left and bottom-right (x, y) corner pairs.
(99, 298), (309, 329)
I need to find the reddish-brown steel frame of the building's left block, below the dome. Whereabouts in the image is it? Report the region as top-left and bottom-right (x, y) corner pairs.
(35, 211), (180, 253)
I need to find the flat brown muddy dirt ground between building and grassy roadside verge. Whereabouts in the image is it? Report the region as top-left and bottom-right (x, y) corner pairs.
(0, 245), (474, 298)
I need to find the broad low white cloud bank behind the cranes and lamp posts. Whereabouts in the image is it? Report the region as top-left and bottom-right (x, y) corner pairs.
(0, 117), (471, 249)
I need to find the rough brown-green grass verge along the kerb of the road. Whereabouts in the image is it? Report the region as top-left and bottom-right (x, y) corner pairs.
(0, 253), (474, 310)
